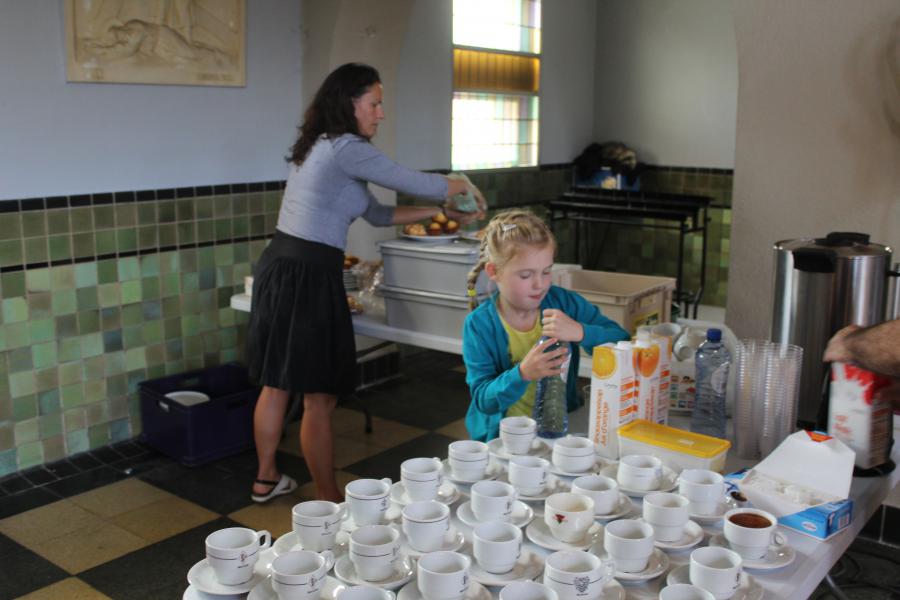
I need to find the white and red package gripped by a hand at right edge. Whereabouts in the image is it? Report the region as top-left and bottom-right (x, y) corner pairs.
(828, 362), (893, 469)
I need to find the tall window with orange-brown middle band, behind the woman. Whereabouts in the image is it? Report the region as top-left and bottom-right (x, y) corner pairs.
(451, 0), (541, 170)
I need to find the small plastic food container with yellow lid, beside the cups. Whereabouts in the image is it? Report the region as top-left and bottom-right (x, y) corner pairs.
(618, 419), (731, 473)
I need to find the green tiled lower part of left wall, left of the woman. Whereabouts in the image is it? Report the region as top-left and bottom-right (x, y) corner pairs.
(0, 188), (281, 476)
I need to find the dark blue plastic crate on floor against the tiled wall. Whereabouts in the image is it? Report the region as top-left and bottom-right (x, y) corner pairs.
(139, 363), (259, 466)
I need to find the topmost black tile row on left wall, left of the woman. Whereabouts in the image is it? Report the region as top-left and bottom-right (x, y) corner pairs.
(0, 179), (286, 213)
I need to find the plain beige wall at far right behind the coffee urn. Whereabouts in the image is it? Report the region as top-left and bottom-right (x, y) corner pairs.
(726, 0), (900, 337)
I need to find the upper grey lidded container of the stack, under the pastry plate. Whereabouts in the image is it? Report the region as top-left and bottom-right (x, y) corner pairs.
(378, 240), (490, 298)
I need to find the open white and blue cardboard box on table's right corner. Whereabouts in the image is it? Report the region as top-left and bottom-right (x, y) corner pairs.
(726, 431), (855, 540)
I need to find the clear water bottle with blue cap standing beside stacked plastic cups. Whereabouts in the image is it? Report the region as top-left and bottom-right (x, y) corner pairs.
(691, 329), (731, 439)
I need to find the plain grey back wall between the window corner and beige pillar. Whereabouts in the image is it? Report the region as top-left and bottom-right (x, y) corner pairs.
(593, 0), (737, 169)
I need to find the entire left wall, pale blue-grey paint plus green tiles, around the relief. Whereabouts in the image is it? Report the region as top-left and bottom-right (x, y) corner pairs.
(0, 0), (300, 477)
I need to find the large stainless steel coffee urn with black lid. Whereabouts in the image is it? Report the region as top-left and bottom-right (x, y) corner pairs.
(771, 232), (891, 429)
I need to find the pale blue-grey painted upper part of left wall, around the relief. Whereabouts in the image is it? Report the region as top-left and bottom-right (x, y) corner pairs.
(0, 0), (300, 200)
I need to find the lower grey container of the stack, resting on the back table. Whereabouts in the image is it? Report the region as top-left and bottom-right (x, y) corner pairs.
(376, 285), (482, 339)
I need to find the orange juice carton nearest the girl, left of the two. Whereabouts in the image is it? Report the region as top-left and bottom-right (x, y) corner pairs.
(588, 342), (636, 460)
